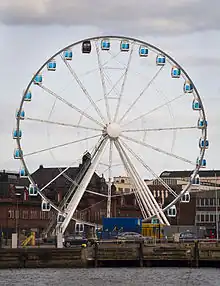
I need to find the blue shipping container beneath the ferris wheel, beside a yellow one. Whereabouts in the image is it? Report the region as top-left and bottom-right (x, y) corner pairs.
(102, 217), (142, 233)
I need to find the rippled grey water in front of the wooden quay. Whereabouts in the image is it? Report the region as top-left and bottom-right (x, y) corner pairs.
(0, 268), (220, 286)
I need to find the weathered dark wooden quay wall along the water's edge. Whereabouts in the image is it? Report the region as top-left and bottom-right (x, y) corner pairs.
(0, 242), (220, 269)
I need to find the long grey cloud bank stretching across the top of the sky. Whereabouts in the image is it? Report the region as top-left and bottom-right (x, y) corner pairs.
(0, 0), (220, 34)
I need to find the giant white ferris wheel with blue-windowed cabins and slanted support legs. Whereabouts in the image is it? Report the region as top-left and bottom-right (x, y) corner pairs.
(13, 36), (209, 233)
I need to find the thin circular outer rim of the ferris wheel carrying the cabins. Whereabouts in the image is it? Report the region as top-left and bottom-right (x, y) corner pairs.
(16, 35), (207, 222)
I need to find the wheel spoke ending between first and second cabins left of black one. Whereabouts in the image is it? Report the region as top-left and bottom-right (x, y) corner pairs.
(60, 55), (106, 123)
